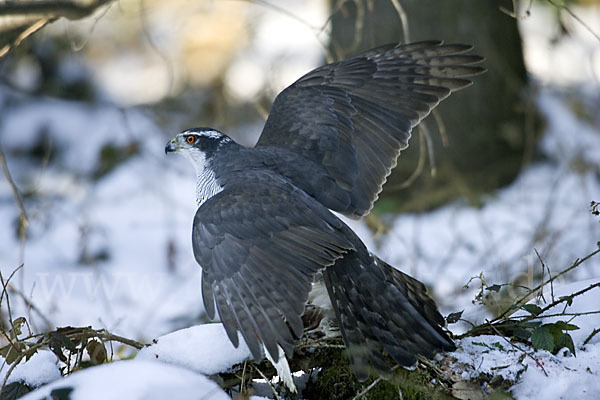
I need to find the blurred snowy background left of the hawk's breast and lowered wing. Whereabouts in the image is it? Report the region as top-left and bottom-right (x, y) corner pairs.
(0, 92), (203, 339)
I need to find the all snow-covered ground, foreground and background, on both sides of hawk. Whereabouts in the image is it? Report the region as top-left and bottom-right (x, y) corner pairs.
(0, 0), (600, 399)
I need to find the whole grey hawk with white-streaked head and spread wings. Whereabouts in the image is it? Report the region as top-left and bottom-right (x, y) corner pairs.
(165, 41), (484, 386)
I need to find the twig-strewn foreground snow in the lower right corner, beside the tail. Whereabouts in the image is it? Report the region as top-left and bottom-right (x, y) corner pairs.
(449, 279), (600, 399)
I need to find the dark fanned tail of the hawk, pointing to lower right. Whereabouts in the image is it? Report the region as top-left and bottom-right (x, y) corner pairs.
(323, 252), (456, 381)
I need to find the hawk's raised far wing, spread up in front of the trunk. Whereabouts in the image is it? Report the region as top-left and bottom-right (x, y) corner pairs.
(256, 41), (485, 218)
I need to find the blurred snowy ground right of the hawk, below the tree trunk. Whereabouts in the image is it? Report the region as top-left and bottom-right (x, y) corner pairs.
(378, 90), (600, 327)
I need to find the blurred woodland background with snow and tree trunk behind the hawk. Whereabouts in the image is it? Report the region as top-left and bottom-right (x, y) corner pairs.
(0, 0), (600, 341)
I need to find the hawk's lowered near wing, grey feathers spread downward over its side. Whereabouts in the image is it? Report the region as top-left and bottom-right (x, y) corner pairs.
(192, 177), (353, 360)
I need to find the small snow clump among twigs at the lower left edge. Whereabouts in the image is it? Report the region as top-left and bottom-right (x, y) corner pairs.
(0, 350), (62, 387)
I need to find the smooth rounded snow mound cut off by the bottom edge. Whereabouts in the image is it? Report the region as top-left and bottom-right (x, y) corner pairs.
(21, 360), (230, 400)
